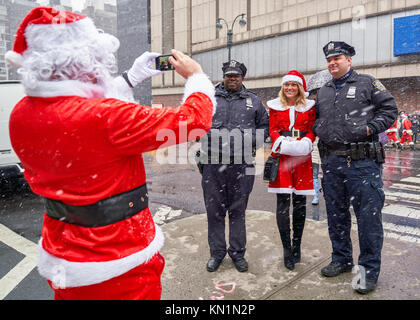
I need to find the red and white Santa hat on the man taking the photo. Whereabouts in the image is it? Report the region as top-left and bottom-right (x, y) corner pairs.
(5, 7), (119, 67)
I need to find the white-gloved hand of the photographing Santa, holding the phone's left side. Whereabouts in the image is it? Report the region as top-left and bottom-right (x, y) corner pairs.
(127, 51), (163, 87)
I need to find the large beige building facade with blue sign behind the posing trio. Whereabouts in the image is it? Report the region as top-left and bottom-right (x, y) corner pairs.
(151, 0), (420, 112)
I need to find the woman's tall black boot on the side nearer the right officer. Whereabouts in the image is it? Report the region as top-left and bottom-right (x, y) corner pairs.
(292, 195), (306, 263)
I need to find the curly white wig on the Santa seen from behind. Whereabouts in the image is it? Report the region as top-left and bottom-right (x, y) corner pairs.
(18, 18), (120, 90)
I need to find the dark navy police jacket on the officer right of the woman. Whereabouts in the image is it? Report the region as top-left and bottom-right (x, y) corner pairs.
(313, 71), (398, 149)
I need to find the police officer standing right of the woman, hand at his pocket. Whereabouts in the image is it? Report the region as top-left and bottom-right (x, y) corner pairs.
(314, 41), (398, 294)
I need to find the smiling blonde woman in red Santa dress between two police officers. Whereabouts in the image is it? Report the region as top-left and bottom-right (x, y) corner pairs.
(267, 70), (315, 270)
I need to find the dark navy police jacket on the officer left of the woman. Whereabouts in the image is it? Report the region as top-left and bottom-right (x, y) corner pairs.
(201, 83), (268, 163)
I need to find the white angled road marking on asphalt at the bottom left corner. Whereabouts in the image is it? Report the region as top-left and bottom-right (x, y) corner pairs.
(0, 224), (38, 300)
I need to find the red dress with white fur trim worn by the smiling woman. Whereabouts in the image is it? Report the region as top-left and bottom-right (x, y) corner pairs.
(267, 98), (315, 195)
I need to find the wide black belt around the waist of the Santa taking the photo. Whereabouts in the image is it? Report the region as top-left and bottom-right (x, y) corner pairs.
(44, 184), (149, 227)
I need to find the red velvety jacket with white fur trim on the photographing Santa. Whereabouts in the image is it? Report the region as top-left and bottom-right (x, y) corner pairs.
(10, 74), (215, 288)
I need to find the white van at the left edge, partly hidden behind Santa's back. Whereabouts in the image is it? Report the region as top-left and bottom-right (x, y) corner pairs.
(0, 81), (25, 185)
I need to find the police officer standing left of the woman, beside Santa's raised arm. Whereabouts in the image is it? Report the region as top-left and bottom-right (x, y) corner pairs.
(200, 60), (268, 272)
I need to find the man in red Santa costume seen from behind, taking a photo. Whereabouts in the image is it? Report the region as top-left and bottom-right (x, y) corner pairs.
(6, 7), (215, 299)
